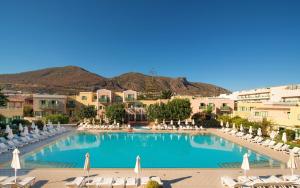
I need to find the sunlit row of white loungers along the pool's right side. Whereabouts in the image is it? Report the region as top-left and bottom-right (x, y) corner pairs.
(221, 128), (292, 156)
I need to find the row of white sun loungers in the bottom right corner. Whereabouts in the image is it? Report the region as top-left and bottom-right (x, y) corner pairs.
(221, 176), (300, 188)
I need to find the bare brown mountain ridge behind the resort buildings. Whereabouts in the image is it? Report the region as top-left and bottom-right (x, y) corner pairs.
(0, 66), (229, 96)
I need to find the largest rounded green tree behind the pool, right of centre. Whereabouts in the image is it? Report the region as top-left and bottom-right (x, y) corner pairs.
(166, 99), (192, 120)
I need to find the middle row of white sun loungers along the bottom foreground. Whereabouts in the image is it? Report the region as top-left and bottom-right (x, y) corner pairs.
(65, 176), (163, 188)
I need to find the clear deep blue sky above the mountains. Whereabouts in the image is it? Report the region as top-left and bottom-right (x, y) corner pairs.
(0, 0), (300, 90)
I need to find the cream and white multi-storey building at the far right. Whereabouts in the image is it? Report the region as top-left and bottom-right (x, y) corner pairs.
(221, 84), (300, 128)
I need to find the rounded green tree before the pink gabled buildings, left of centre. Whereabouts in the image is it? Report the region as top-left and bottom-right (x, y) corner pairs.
(105, 104), (125, 122)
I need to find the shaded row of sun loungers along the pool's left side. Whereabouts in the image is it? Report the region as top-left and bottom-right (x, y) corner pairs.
(0, 127), (66, 153)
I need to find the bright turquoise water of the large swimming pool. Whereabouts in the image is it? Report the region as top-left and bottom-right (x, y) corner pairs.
(22, 133), (280, 168)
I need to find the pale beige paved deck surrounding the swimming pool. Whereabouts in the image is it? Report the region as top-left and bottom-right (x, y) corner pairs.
(0, 129), (300, 188)
